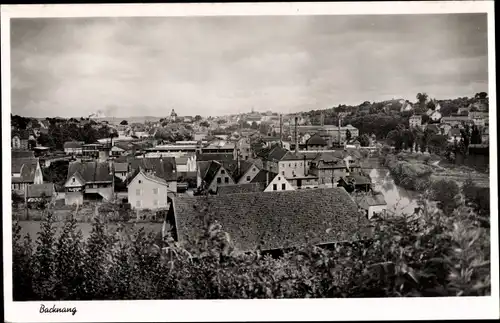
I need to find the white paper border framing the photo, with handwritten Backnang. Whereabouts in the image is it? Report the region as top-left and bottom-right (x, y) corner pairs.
(1, 1), (500, 322)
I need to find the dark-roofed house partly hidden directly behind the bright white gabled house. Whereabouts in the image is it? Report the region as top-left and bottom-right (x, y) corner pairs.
(127, 157), (177, 195)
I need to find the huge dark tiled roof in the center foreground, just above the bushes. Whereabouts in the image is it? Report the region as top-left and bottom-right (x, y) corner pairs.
(173, 188), (369, 251)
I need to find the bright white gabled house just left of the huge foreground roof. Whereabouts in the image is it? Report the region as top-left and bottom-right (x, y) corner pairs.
(127, 166), (173, 210)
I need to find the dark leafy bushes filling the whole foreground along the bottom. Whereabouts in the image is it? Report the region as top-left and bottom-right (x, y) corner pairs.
(13, 200), (490, 301)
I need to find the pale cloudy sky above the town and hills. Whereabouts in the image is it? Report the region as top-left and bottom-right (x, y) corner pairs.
(11, 14), (488, 117)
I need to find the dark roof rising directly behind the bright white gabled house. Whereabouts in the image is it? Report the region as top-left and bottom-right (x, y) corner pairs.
(129, 157), (177, 182)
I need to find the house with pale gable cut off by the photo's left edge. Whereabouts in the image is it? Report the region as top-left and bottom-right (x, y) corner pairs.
(11, 157), (43, 194)
